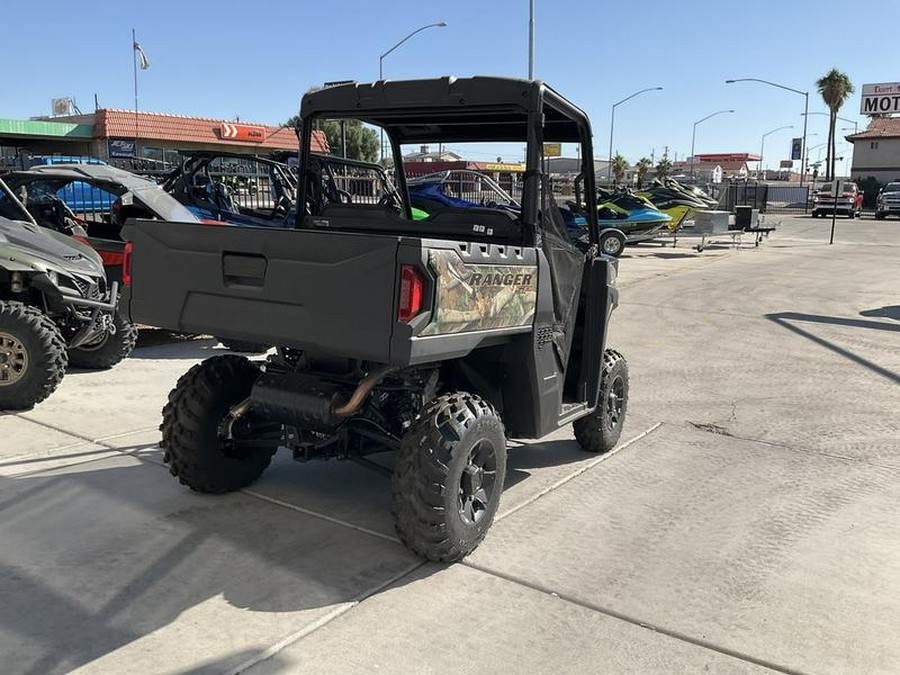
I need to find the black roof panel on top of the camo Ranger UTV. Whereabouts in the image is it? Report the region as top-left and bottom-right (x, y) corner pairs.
(300, 76), (588, 143)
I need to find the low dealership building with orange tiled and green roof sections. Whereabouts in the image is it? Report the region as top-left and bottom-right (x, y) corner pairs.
(0, 108), (328, 168)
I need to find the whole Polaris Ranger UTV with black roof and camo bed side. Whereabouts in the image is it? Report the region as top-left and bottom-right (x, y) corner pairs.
(125, 77), (628, 561)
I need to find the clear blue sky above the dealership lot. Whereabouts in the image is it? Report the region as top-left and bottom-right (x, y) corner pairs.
(0, 0), (900, 162)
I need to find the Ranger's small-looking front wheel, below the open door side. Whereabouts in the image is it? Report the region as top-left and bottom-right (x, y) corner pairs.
(572, 349), (628, 454)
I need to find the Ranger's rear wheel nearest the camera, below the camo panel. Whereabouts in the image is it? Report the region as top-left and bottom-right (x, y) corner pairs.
(392, 392), (506, 562)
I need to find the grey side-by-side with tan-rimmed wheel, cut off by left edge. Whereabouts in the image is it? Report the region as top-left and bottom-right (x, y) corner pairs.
(0, 180), (137, 410)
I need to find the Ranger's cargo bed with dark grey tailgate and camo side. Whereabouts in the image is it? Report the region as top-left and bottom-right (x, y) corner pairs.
(123, 220), (538, 365)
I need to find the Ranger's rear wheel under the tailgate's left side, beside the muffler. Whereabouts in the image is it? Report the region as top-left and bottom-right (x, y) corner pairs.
(160, 354), (281, 494)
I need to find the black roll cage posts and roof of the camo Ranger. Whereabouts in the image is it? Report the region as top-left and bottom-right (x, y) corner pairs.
(294, 77), (599, 244)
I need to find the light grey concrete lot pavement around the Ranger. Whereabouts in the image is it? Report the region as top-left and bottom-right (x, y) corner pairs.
(0, 218), (900, 674)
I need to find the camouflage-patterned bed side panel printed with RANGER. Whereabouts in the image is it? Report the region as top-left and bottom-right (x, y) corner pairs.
(420, 250), (537, 335)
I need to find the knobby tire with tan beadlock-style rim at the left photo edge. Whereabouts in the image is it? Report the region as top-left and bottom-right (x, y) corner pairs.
(0, 301), (68, 410)
